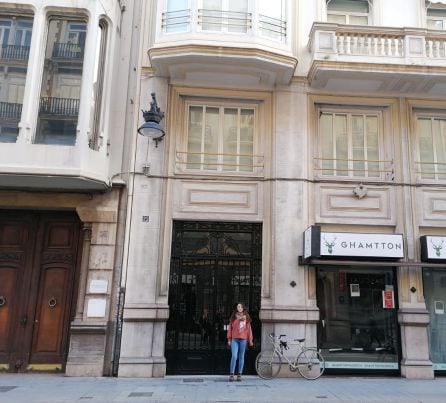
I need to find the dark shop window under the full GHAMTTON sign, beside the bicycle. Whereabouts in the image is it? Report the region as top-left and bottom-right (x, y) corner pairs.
(317, 267), (399, 372)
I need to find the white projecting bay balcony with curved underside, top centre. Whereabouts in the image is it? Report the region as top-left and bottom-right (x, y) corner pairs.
(149, 1), (297, 85)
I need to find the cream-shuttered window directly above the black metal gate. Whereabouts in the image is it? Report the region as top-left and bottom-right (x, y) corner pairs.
(187, 105), (255, 172)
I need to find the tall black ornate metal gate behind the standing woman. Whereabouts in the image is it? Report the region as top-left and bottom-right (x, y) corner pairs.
(166, 221), (262, 375)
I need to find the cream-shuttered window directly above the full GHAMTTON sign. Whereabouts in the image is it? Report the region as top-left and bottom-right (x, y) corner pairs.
(317, 110), (382, 178)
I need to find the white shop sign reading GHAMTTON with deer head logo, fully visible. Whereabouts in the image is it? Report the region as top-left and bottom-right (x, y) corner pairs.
(304, 225), (404, 259)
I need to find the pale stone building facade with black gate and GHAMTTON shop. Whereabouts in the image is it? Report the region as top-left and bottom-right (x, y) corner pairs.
(118, 0), (446, 378)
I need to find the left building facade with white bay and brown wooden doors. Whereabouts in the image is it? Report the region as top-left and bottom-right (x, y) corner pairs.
(0, 0), (138, 376)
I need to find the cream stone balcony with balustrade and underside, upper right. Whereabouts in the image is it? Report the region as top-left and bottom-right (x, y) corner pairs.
(308, 23), (446, 95)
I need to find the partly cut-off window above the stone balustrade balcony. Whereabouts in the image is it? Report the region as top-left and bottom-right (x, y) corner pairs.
(327, 0), (369, 25)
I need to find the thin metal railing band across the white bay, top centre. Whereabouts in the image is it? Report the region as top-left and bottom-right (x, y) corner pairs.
(161, 9), (287, 42)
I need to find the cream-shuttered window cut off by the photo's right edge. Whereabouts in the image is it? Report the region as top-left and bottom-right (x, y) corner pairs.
(416, 115), (446, 179)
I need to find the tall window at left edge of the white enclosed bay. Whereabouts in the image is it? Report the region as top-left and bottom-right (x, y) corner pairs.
(0, 15), (33, 143)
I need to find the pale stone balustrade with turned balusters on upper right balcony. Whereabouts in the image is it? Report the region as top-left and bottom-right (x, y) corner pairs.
(308, 23), (446, 64)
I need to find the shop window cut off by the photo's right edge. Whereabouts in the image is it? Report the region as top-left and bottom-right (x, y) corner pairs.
(423, 268), (446, 370)
